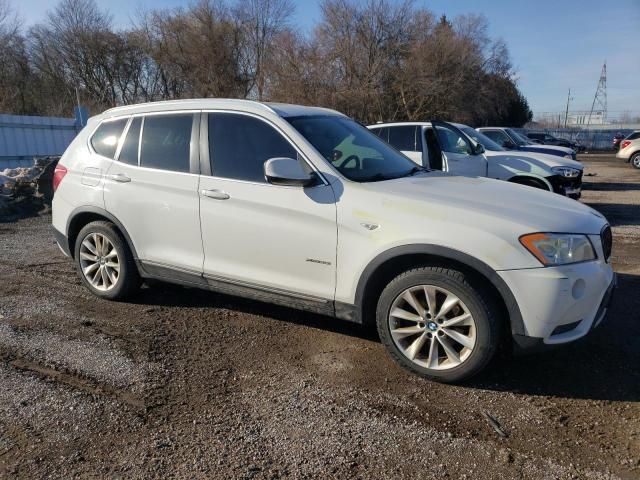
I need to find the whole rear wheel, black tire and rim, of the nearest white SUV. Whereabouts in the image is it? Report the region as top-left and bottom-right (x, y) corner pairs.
(74, 221), (141, 300)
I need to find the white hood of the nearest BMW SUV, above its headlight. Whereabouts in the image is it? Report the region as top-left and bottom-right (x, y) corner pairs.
(361, 172), (607, 236)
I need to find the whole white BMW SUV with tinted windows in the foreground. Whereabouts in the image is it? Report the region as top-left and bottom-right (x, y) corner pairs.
(52, 99), (615, 382)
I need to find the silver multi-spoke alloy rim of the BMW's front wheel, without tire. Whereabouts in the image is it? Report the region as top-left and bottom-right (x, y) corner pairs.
(388, 285), (476, 370)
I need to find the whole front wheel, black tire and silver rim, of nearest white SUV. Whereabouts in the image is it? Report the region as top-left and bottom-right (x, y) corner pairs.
(376, 267), (502, 383)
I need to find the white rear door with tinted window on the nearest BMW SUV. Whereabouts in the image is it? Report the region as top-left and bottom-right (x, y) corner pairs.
(104, 112), (203, 275)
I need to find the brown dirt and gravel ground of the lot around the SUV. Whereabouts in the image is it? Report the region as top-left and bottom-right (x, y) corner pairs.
(0, 156), (640, 480)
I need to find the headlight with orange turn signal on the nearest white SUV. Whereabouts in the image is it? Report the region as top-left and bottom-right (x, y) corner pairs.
(520, 233), (596, 266)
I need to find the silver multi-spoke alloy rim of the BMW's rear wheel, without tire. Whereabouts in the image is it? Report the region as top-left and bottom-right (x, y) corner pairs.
(80, 233), (120, 292)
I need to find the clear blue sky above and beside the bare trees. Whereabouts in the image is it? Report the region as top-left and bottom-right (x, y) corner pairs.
(10, 0), (640, 118)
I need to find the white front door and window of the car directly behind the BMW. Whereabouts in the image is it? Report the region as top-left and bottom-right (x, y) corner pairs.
(431, 121), (487, 177)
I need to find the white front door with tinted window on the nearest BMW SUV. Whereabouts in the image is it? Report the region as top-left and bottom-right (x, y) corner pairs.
(199, 112), (337, 300)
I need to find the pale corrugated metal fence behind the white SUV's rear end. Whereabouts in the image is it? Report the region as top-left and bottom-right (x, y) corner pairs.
(0, 107), (88, 171)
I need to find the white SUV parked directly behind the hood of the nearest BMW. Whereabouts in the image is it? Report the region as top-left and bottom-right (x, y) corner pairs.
(368, 121), (583, 199)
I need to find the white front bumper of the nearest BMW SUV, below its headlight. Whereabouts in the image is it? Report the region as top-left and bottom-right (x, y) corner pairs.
(498, 256), (616, 352)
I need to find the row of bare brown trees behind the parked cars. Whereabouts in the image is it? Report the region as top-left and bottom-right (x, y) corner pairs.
(0, 0), (532, 126)
